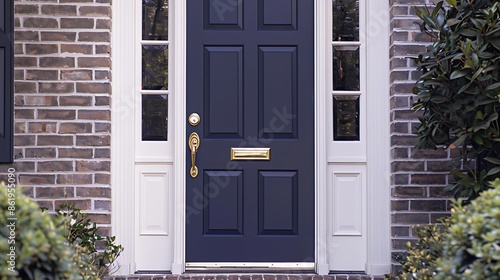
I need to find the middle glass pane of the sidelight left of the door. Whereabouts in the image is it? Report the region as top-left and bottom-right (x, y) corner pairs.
(142, 45), (168, 90)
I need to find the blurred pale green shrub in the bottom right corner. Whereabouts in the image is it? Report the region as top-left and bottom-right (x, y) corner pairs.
(436, 178), (500, 280)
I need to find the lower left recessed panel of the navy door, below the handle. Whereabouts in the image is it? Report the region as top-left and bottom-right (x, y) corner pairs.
(203, 171), (243, 235)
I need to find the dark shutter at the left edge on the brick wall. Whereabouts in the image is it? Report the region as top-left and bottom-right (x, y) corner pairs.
(0, 0), (14, 163)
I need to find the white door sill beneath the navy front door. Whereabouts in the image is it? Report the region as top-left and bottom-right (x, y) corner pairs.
(186, 262), (315, 273)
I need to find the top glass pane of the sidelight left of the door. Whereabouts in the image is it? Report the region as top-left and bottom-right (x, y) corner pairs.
(142, 0), (168, 41)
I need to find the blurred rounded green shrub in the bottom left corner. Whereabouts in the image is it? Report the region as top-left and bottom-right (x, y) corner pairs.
(0, 184), (81, 280)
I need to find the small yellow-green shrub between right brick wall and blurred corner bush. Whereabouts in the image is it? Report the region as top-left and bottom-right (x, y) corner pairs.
(385, 219), (449, 280)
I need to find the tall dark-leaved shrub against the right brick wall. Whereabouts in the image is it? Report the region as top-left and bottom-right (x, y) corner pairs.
(413, 0), (500, 200)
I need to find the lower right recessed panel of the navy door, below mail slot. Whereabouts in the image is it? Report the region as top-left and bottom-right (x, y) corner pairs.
(259, 171), (298, 235)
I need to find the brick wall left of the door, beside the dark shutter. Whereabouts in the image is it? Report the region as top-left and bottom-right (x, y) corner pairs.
(0, 0), (111, 231)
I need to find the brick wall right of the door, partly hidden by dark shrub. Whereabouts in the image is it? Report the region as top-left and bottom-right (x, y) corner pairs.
(390, 0), (454, 274)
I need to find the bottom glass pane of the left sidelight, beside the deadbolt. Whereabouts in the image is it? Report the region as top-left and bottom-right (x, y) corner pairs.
(142, 94), (168, 141)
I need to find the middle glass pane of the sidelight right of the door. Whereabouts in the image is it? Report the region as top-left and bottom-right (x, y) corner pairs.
(333, 46), (360, 91)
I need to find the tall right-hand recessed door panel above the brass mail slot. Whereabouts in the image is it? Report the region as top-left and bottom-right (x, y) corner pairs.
(259, 46), (298, 138)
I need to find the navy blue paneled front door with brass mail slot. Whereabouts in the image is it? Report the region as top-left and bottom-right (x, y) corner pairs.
(186, 0), (315, 263)
